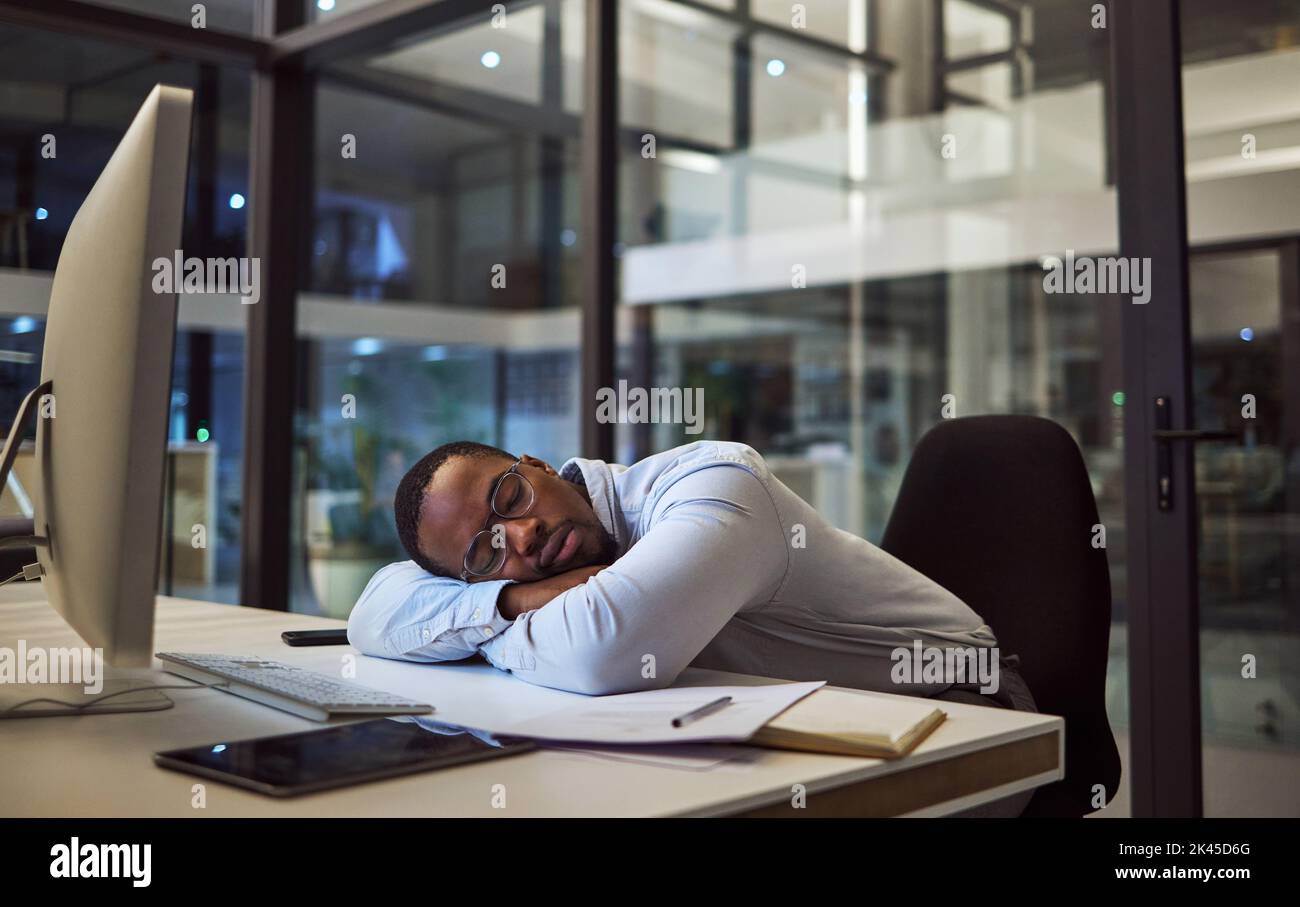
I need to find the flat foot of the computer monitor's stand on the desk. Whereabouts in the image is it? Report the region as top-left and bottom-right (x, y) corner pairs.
(0, 665), (178, 719)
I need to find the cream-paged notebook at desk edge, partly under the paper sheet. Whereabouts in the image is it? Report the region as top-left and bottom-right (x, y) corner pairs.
(749, 687), (948, 759)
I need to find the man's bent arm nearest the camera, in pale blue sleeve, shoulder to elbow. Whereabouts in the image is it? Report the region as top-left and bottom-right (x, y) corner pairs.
(480, 465), (789, 695)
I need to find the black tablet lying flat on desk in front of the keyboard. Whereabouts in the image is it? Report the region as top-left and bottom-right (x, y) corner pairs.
(153, 717), (537, 797)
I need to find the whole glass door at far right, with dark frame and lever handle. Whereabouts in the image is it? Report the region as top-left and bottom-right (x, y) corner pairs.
(1112, 0), (1300, 816)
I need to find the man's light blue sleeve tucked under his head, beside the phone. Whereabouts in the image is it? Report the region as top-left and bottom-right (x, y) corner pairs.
(347, 560), (510, 661)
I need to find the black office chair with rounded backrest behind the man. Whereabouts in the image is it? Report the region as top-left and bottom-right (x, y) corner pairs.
(881, 416), (1119, 816)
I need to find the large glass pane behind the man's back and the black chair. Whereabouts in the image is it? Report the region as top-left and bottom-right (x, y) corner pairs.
(608, 0), (1128, 808)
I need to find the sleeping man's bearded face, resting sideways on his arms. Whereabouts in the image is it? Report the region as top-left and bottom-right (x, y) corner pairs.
(420, 455), (615, 582)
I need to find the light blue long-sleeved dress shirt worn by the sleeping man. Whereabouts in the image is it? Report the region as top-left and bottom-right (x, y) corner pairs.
(347, 441), (997, 695)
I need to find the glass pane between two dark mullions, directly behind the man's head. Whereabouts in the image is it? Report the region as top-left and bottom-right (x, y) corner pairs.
(294, 3), (582, 617)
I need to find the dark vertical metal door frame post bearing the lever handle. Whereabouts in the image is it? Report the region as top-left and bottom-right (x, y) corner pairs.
(1110, 0), (1201, 817)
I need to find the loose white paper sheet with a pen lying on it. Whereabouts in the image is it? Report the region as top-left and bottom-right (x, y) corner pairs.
(508, 681), (826, 743)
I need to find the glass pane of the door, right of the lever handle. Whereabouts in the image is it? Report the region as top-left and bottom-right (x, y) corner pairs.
(1179, 0), (1300, 816)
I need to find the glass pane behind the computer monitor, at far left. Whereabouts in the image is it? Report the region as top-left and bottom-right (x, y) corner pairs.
(0, 19), (251, 602)
